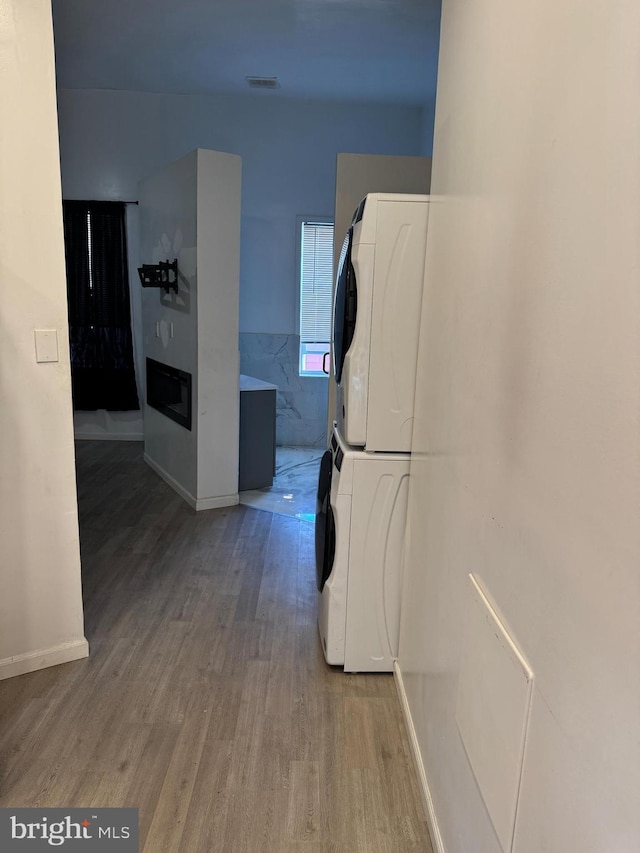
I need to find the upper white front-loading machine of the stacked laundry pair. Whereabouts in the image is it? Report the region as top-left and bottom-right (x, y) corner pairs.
(333, 193), (431, 453)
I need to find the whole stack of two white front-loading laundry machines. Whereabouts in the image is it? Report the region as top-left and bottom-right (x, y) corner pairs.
(316, 193), (430, 672)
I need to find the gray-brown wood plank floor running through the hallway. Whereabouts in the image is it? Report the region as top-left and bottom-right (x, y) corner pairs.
(0, 442), (431, 853)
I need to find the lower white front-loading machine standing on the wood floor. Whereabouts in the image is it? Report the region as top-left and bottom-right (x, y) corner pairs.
(316, 425), (409, 672)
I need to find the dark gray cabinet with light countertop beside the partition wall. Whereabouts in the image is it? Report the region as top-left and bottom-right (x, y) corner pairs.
(238, 374), (278, 492)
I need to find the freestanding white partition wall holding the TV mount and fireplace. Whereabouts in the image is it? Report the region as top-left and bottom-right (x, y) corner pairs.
(139, 149), (241, 509)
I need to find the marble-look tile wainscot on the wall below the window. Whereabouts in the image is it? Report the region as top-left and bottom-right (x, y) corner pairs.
(239, 332), (329, 448)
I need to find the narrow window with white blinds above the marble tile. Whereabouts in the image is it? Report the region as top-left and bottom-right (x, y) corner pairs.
(300, 220), (333, 376)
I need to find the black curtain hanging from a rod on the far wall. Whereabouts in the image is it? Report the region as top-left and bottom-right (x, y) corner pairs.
(63, 201), (140, 411)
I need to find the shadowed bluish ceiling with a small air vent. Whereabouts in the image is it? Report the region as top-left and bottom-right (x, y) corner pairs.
(52, 0), (440, 105)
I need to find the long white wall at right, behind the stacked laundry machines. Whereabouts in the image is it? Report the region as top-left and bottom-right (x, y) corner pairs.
(399, 0), (640, 853)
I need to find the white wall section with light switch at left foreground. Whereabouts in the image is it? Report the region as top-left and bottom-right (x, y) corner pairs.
(0, 0), (88, 678)
